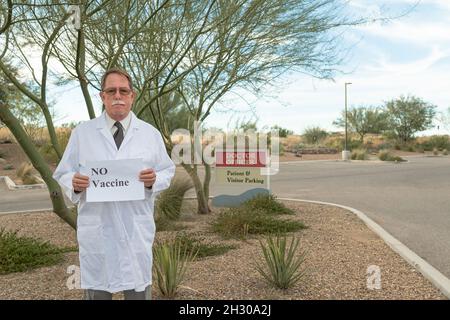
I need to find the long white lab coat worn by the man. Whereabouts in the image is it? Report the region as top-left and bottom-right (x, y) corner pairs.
(53, 113), (175, 293)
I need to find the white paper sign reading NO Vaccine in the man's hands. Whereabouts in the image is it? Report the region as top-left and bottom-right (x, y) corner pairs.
(81, 159), (145, 202)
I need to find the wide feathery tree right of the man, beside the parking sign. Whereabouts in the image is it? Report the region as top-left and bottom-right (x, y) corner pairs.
(125, 0), (368, 213)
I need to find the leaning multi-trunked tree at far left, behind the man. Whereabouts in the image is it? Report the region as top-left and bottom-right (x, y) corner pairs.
(0, 0), (168, 228)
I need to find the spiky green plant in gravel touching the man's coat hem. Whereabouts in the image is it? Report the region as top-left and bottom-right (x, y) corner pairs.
(153, 241), (195, 298)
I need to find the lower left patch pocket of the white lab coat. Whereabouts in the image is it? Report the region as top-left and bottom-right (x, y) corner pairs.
(77, 215), (104, 256)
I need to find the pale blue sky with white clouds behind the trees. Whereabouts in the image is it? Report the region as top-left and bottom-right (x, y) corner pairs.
(55, 0), (450, 135)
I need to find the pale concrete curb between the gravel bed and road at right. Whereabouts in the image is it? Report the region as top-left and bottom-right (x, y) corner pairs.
(278, 198), (450, 299)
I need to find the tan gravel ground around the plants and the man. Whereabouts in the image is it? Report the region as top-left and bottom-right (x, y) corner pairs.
(0, 202), (446, 300)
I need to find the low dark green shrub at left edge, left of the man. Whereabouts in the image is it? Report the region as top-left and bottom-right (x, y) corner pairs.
(0, 229), (77, 274)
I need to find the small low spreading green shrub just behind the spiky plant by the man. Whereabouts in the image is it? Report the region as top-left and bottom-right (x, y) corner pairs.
(175, 232), (236, 258)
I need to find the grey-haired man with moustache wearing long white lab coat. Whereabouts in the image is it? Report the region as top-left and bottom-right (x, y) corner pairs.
(53, 68), (175, 300)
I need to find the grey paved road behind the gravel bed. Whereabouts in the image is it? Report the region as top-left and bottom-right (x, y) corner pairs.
(0, 157), (450, 278)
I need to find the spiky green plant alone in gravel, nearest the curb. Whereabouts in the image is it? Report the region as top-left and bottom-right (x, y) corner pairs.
(256, 237), (306, 289)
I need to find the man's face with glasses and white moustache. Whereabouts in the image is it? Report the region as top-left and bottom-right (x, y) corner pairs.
(100, 73), (135, 121)
